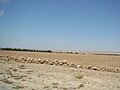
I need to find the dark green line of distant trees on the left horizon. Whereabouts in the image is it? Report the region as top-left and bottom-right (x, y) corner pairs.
(0, 48), (52, 53)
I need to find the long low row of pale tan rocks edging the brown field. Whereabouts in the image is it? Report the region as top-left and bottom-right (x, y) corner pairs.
(0, 55), (120, 73)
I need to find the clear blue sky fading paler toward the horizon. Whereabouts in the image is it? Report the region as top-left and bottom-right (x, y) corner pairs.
(0, 0), (120, 52)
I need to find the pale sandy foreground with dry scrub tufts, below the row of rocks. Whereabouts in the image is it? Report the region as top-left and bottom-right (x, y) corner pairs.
(0, 61), (120, 90)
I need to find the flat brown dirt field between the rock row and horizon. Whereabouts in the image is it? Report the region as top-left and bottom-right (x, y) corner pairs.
(0, 51), (120, 68)
